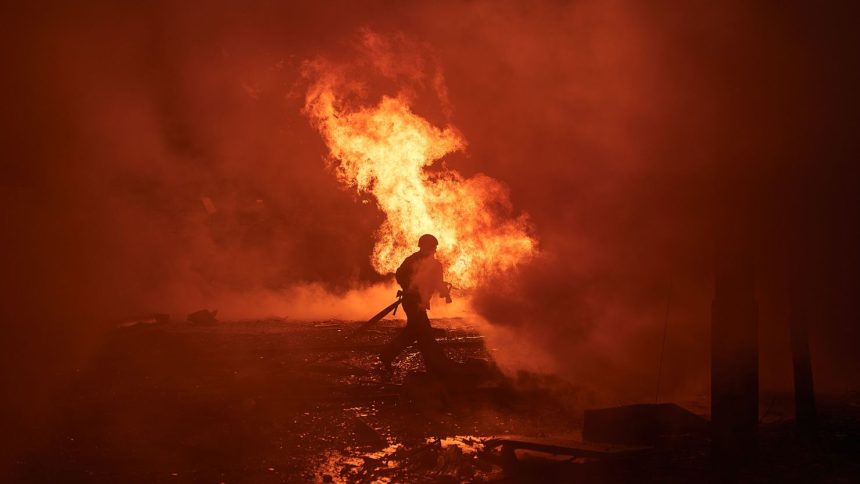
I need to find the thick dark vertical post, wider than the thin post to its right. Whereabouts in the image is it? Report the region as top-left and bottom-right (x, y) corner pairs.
(711, 248), (758, 471)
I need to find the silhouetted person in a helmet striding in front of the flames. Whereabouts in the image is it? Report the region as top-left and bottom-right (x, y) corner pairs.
(379, 234), (451, 373)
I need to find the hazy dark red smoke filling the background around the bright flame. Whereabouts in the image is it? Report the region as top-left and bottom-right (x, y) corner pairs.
(2, 2), (858, 468)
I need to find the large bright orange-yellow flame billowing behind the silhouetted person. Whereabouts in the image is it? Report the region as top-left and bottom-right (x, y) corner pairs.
(306, 81), (536, 288)
